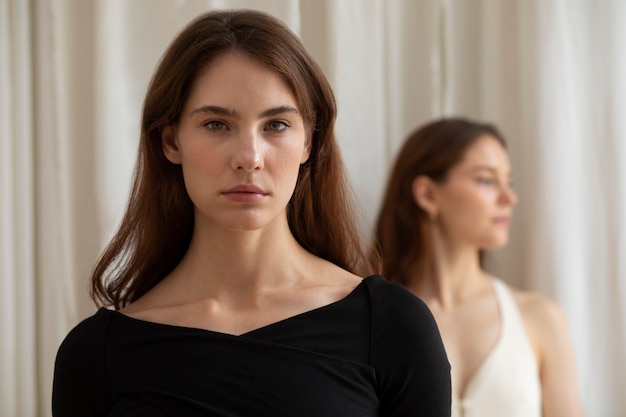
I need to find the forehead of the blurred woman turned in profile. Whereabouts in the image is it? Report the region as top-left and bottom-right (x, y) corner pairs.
(455, 135), (510, 172)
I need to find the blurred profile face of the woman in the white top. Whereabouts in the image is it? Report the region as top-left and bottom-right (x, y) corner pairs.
(428, 136), (517, 249)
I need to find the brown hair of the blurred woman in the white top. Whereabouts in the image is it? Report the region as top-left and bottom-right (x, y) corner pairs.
(375, 118), (506, 285)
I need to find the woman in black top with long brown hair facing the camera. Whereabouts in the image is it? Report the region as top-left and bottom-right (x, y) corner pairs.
(52, 11), (450, 417)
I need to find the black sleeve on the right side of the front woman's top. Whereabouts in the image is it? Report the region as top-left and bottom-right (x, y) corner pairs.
(370, 280), (452, 417)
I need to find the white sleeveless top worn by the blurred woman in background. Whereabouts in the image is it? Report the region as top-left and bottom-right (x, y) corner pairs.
(452, 278), (541, 417)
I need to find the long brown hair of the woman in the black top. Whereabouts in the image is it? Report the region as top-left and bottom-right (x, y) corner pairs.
(91, 10), (375, 308)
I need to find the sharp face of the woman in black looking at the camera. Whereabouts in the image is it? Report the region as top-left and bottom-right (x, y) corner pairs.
(163, 52), (309, 230)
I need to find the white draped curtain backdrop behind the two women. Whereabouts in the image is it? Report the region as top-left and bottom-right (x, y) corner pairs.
(0, 0), (626, 417)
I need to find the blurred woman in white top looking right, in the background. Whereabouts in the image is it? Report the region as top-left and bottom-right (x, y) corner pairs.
(376, 118), (583, 417)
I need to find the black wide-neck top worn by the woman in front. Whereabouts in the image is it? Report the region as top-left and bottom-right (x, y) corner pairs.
(52, 275), (451, 417)
